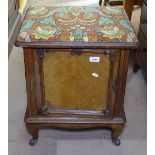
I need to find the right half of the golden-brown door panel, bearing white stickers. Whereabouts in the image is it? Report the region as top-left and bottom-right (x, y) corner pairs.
(76, 53), (110, 110)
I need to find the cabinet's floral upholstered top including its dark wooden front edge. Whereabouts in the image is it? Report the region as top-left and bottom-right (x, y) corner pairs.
(16, 6), (138, 49)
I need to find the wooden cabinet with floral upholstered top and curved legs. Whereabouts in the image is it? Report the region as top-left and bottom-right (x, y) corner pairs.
(16, 7), (138, 145)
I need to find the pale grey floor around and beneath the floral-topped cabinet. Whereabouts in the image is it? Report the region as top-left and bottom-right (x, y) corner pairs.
(8, 0), (147, 155)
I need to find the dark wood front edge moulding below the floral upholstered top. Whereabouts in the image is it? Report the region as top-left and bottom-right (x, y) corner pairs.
(15, 41), (139, 50)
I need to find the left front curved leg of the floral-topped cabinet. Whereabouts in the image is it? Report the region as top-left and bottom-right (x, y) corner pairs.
(26, 124), (38, 146)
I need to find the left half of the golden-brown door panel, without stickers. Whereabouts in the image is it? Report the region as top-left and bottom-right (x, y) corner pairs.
(43, 52), (76, 109)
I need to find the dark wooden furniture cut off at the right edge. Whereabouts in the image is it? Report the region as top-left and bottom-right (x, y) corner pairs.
(133, 0), (147, 81)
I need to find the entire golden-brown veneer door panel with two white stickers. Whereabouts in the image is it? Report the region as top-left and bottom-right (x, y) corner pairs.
(43, 51), (110, 110)
